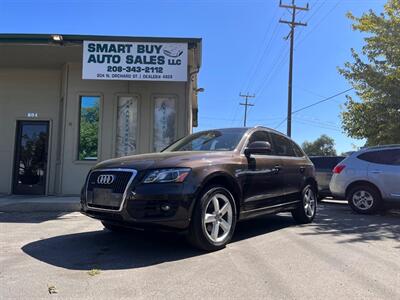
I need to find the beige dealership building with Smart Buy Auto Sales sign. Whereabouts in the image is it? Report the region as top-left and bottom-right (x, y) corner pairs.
(0, 35), (201, 195)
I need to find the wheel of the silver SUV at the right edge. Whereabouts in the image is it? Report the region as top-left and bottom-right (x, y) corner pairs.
(346, 185), (382, 215)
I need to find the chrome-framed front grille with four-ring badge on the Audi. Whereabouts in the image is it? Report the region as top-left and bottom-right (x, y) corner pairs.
(86, 169), (136, 211)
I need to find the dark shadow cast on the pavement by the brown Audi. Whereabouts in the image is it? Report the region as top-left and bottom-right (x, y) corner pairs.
(22, 216), (294, 270)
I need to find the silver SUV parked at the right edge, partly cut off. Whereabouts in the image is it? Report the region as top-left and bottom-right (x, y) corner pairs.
(329, 145), (400, 214)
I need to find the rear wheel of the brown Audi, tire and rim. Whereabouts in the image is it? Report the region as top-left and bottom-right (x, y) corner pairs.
(292, 185), (317, 224)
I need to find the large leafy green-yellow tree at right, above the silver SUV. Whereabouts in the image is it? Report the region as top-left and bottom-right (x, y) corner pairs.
(339, 0), (400, 146)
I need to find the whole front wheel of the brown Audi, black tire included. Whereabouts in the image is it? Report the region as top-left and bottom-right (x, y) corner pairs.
(187, 186), (236, 251)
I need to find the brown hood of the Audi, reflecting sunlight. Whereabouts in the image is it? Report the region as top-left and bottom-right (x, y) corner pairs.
(94, 151), (234, 171)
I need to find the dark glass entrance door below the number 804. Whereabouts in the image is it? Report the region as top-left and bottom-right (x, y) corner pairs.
(13, 121), (49, 195)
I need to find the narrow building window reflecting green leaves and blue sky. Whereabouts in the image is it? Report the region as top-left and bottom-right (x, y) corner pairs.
(79, 103), (99, 160)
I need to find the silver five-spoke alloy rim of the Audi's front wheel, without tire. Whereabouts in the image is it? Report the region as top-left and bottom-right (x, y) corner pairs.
(203, 193), (233, 243)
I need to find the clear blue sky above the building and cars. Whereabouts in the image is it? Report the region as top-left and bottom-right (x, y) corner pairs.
(0, 0), (386, 153)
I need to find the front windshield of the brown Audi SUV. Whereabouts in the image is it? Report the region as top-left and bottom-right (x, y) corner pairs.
(163, 128), (246, 152)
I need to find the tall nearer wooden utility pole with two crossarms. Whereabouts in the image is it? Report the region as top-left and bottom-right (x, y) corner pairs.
(279, 0), (309, 136)
